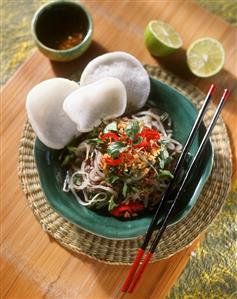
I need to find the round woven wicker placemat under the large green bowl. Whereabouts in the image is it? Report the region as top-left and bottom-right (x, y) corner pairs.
(19, 66), (231, 264)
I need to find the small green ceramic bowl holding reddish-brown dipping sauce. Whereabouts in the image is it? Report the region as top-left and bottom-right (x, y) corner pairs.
(31, 0), (93, 61)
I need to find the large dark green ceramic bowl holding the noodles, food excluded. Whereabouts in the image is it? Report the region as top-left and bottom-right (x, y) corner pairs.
(35, 79), (213, 239)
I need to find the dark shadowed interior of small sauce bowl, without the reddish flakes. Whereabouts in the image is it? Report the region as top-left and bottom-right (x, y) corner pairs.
(34, 1), (90, 50)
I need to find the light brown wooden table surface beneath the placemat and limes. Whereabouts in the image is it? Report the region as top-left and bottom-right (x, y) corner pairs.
(0, 1), (237, 299)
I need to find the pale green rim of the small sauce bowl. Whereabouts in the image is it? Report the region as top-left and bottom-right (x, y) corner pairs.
(31, 0), (94, 54)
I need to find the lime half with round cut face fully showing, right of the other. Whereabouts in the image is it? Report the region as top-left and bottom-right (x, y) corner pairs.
(187, 37), (225, 78)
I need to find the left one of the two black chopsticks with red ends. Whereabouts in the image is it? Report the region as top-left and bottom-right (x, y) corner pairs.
(121, 84), (215, 292)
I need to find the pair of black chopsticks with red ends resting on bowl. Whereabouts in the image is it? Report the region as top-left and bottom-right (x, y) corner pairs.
(121, 84), (229, 293)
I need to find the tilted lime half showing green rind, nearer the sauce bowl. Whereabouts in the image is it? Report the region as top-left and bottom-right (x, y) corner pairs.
(144, 21), (183, 57)
